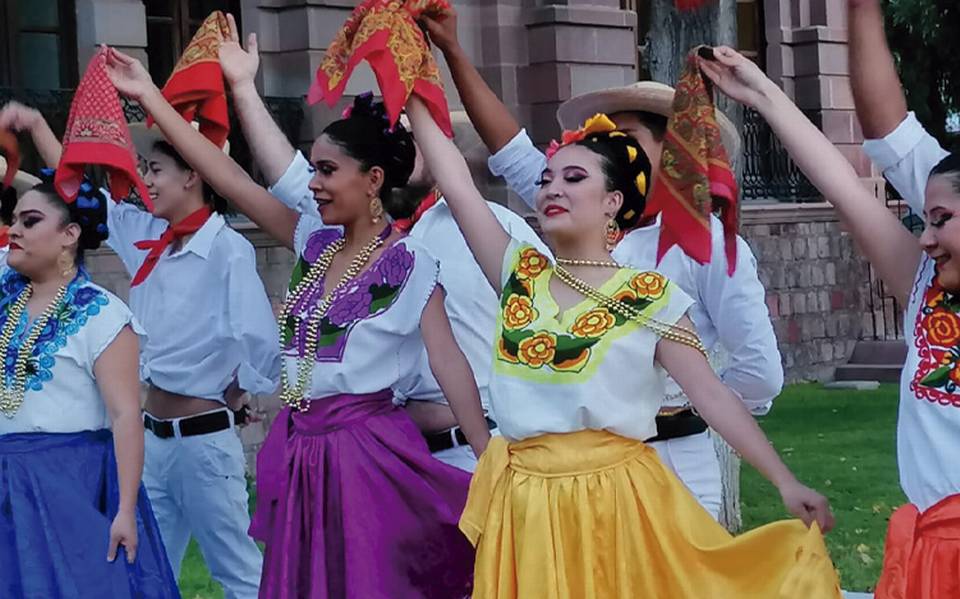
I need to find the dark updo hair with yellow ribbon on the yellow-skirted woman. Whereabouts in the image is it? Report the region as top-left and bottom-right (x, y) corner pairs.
(575, 131), (652, 231)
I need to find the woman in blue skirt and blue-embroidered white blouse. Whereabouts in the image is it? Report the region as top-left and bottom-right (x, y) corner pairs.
(0, 171), (180, 599)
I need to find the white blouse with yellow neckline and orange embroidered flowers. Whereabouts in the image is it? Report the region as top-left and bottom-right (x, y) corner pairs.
(491, 240), (693, 440)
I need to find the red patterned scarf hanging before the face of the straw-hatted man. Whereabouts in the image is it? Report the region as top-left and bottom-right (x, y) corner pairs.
(644, 47), (737, 275)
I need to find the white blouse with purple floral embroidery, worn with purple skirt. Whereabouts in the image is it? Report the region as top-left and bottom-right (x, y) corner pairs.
(281, 215), (439, 399)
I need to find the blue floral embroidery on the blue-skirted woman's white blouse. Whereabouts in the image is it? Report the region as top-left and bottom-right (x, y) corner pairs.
(0, 268), (110, 391)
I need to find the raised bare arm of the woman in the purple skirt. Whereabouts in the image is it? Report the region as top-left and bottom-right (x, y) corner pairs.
(107, 48), (300, 249)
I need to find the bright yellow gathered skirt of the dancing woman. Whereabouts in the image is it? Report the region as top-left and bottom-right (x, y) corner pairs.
(460, 431), (842, 599)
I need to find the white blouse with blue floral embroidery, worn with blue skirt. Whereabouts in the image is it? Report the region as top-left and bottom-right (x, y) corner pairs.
(0, 268), (139, 434)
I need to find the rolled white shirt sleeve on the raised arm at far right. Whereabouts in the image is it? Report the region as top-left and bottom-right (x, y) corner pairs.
(863, 112), (948, 215)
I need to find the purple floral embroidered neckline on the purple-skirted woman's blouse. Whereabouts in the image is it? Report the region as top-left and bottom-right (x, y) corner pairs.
(283, 229), (415, 362)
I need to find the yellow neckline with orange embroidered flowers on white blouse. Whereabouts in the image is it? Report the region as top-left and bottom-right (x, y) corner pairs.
(496, 247), (669, 373)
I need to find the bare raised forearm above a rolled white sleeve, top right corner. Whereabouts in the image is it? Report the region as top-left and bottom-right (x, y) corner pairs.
(847, 0), (907, 139)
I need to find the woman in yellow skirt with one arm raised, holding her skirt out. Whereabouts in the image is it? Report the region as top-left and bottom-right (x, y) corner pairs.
(407, 91), (840, 599)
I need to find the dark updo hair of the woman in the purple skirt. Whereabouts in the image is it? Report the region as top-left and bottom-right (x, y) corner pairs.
(323, 92), (417, 218)
